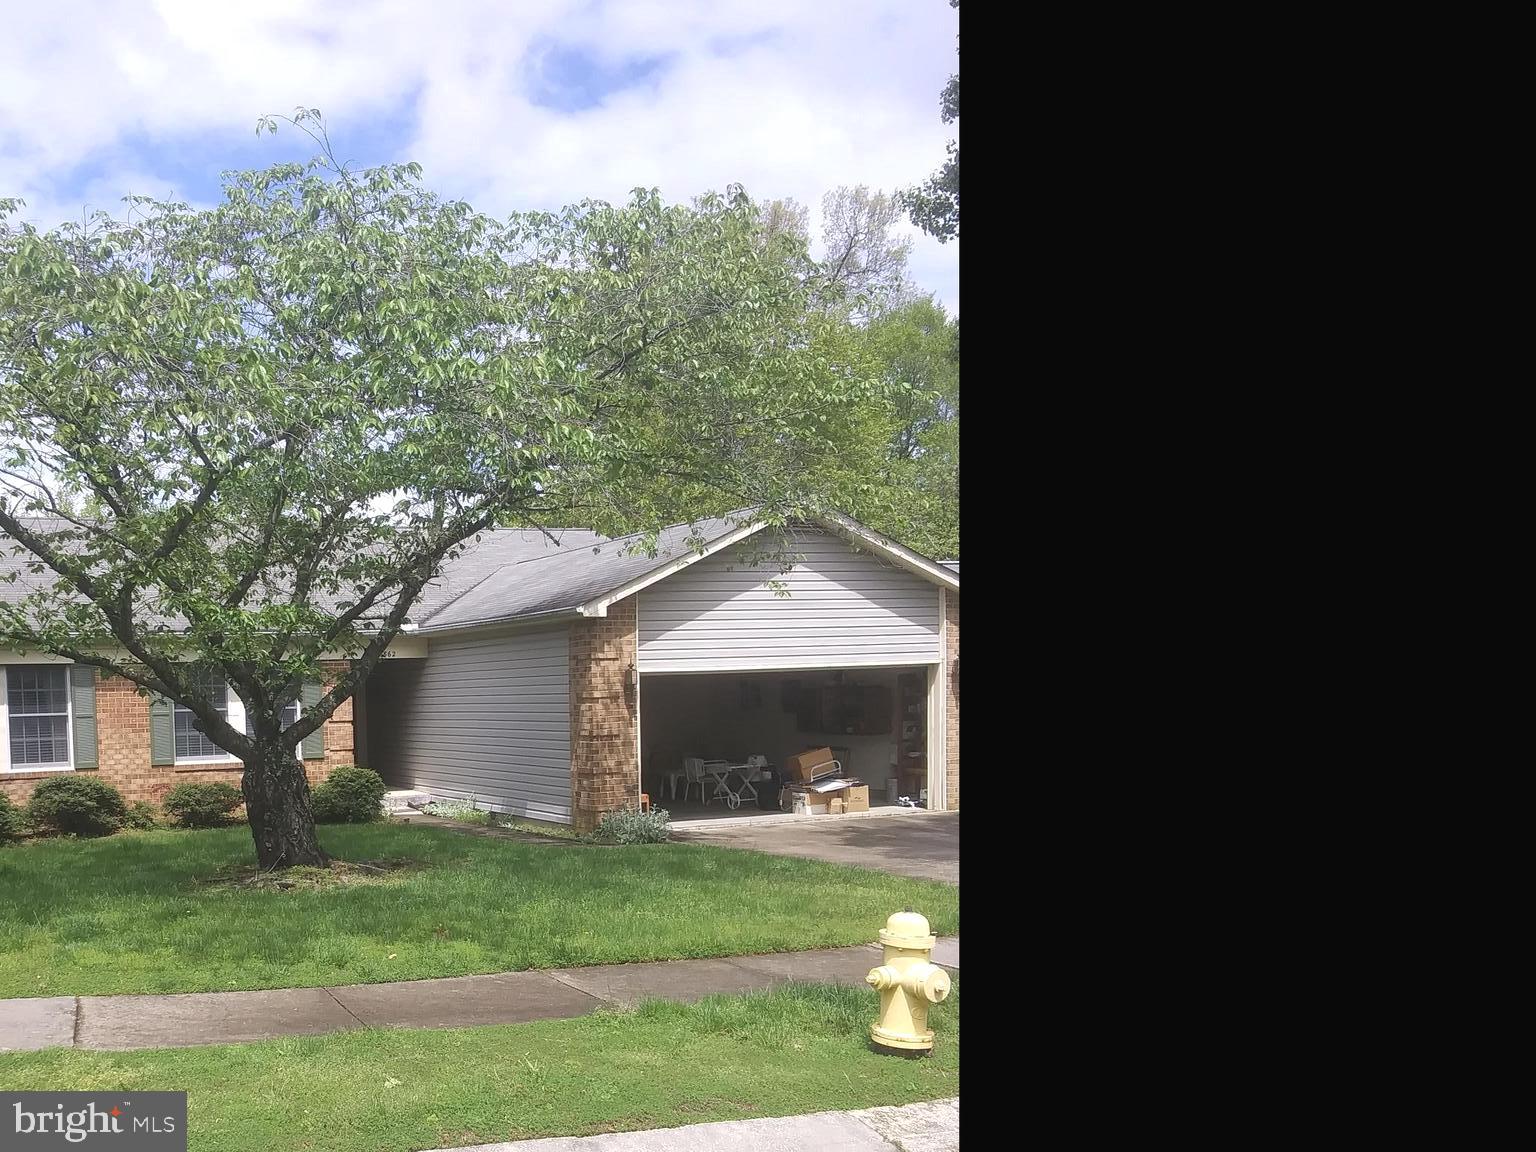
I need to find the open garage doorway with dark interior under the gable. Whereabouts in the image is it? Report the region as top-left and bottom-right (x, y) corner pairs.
(641, 665), (929, 820)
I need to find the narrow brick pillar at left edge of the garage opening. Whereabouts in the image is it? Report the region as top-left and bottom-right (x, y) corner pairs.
(570, 596), (641, 833)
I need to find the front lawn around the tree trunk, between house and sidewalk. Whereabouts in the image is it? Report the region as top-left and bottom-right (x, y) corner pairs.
(0, 825), (960, 997)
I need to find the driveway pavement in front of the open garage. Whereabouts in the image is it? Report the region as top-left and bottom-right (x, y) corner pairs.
(673, 811), (960, 885)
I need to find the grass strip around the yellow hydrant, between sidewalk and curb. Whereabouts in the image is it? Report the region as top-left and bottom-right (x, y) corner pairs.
(0, 980), (960, 1152)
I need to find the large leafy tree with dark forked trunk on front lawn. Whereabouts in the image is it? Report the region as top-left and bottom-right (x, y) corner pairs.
(0, 109), (882, 868)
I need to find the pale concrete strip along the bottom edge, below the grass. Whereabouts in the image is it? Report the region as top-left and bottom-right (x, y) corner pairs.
(444, 1097), (960, 1152)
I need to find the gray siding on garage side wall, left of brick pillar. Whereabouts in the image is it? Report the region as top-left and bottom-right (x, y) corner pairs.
(369, 628), (571, 823)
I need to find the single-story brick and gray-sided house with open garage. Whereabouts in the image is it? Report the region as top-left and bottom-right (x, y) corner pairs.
(0, 516), (960, 829)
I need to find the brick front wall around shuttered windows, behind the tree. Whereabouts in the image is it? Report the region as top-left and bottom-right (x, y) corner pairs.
(0, 660), (355, 805)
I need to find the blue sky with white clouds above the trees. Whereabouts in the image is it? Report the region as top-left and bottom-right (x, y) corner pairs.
(0, 0), (960, 312)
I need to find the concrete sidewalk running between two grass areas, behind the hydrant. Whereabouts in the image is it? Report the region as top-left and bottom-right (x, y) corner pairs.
(0, 935), (960, 1052)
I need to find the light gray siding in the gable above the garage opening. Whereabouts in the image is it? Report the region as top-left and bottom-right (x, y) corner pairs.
(639, 533), (942, 673)
